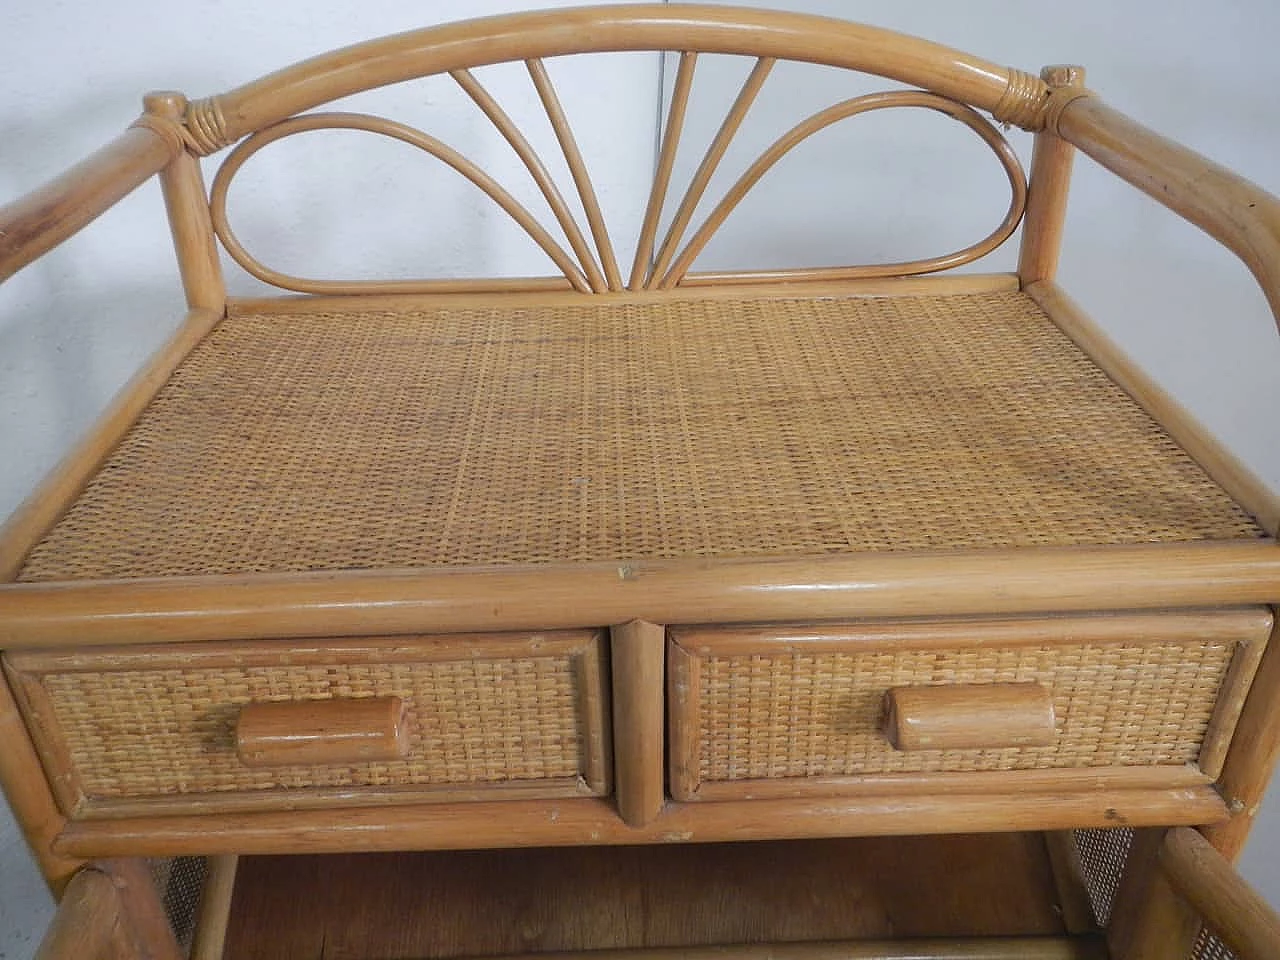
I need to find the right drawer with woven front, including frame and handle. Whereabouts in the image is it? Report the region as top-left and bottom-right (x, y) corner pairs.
(667, 609), (1271, 800)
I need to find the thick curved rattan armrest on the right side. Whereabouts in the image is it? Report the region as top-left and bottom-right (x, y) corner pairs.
(1057, 96), (1280, 337)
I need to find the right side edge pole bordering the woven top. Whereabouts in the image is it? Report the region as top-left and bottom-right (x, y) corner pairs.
(1027, 282), (1280, 536)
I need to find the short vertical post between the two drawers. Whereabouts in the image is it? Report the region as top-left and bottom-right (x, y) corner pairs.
(611, 620), (666, 827)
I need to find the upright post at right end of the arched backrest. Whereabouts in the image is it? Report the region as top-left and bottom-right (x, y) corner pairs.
(1018, 65), (1084, 287)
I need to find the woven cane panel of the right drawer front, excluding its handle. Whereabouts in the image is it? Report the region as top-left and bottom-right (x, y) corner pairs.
(699, 643), (1234, 781)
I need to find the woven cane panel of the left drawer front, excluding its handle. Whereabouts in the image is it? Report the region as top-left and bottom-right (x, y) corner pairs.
(44, 657), (582, 799)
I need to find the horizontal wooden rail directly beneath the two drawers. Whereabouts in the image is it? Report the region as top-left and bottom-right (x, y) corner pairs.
(54, 786), (1226, 856)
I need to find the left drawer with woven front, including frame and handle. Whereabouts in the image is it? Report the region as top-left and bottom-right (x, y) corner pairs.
(5, 631), (609, 818)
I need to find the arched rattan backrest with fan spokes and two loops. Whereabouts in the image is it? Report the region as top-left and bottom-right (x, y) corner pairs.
(152, 4), (1051, 294)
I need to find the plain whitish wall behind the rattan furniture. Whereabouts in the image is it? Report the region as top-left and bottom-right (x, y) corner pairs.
(0, 0), (1280, 960)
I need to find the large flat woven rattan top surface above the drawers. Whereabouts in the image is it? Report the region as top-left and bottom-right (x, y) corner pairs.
(20, 293), (1261, 581)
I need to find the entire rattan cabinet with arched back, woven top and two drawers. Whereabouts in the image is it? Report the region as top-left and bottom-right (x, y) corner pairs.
(0, 5), (1280, 960)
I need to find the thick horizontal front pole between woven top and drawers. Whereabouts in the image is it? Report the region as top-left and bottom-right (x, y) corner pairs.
(0, 541), (1280, 649)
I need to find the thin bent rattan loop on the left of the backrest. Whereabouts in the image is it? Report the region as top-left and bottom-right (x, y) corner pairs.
(210, 113), (591, 293)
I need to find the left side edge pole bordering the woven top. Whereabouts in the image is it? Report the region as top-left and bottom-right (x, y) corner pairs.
(0, 310), (221, 585)
